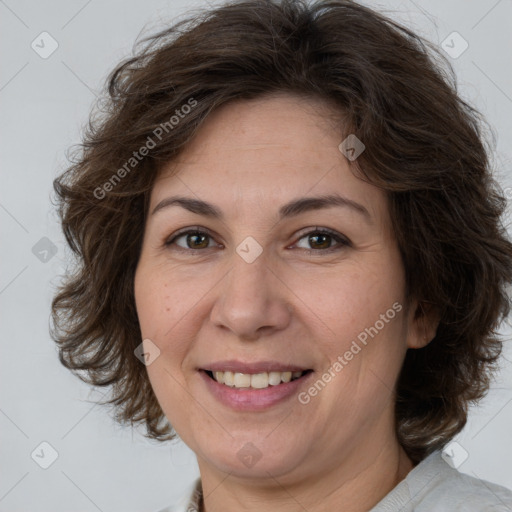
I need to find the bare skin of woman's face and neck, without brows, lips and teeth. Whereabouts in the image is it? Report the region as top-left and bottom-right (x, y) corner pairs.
(135, 94), (436, 512)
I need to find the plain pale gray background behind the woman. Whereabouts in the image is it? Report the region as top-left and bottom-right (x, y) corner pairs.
(0, 0), (512, 512)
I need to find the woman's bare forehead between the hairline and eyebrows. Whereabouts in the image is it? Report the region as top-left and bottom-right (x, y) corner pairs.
(150, 95), (387, 228)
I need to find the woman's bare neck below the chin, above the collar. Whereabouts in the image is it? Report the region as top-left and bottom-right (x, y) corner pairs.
(199, 443), (414, 512)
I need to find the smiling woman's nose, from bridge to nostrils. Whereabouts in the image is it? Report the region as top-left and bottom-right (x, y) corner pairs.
(210, 248), (292, 341)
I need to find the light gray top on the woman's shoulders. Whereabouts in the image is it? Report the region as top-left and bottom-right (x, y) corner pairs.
(159, 451), (512, 512)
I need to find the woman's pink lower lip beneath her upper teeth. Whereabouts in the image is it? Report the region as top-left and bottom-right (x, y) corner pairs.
(199, 370), (313, 411)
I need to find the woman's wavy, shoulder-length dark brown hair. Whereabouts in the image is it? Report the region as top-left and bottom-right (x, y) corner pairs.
(52, 0), (512, 462)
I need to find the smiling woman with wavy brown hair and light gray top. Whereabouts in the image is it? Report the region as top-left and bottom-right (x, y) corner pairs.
(53, 0), (512, 512)
